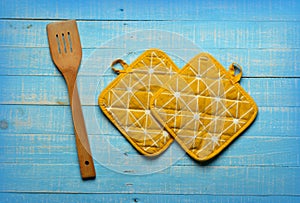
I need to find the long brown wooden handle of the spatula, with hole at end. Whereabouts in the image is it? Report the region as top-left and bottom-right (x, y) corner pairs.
(69, 82), (96, 179)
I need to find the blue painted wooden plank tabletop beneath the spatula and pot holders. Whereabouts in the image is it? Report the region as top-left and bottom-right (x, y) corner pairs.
(0, 0), (300, 203)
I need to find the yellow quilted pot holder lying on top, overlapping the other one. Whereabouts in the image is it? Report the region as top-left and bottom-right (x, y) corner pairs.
(151, 53), (258, 161)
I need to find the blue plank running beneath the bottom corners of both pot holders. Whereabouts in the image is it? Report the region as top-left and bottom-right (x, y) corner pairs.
(0, 133), (300, 167)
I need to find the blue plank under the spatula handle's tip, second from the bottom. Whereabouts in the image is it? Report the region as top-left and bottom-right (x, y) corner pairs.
(0, 163), (300, 196)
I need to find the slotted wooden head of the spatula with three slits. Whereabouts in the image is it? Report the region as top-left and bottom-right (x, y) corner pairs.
(47, 20), (82, 74)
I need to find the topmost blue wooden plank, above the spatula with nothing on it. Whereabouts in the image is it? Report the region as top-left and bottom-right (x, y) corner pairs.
(0, 0), (300, 21)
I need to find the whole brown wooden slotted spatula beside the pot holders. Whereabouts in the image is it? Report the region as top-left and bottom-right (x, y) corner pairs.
(47, 20), (96, 179)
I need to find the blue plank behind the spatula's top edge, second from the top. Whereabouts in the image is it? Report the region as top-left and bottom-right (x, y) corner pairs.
(0, 20), (300, 50)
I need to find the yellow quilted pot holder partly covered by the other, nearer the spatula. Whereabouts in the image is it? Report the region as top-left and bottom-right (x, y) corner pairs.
(98, 49), (178, 156)
